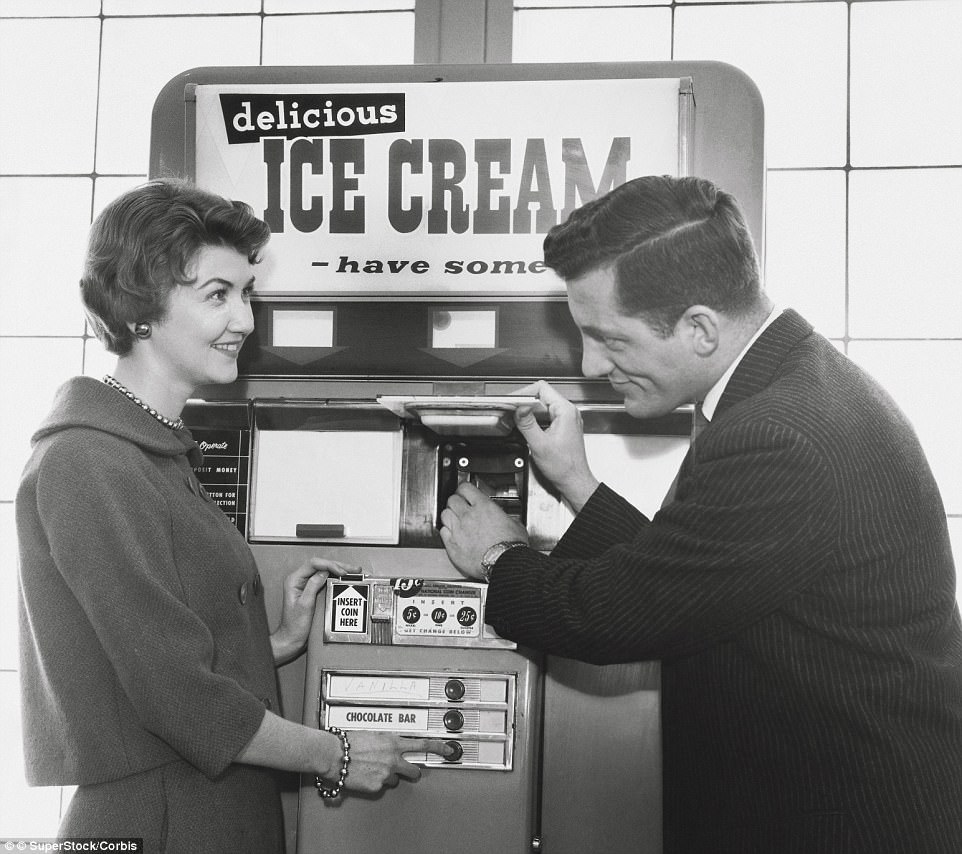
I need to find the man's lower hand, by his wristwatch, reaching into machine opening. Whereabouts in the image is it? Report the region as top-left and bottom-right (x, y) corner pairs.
(440, 483), (528, 579)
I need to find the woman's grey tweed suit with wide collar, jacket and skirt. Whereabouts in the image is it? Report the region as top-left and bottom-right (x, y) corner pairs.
(16, 377), (281, 854)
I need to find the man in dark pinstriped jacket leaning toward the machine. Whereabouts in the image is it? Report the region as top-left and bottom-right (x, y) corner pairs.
(441, 177), (962, 854)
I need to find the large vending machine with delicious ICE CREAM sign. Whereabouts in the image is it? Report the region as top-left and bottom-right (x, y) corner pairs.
(151, 62), (763, 854)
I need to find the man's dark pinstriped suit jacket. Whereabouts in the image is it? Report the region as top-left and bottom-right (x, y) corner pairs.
(487, 311), (962, 854)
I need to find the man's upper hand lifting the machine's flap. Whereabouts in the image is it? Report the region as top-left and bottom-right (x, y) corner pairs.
(515, 380), (598, 513)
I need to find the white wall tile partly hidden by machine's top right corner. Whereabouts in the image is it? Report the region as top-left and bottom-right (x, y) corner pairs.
(674, 2), (848, 167)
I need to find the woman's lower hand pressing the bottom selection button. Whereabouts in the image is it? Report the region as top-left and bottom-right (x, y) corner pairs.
(321, 730), (452, 793)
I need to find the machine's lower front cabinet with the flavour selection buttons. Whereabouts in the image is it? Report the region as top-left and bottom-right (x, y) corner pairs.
(297, 579), (542, 854)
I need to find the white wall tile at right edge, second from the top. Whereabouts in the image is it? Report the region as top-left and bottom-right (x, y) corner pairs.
(849, 169), (962, 338)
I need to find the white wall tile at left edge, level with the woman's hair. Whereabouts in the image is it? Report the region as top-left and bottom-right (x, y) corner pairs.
(0, 178), (93, 335)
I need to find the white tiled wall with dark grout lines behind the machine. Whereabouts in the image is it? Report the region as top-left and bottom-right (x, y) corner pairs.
(0, 0), (962, 836)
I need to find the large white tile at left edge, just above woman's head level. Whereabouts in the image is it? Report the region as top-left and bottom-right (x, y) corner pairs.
(0, 18), (100, 174)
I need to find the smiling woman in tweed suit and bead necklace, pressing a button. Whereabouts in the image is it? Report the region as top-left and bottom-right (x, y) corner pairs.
(17, 182), (447, 854)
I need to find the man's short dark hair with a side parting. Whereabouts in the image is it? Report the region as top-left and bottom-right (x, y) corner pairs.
(544, 176), (761, 337)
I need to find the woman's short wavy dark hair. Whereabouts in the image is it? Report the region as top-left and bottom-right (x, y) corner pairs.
(80, 180), (270, 356)
